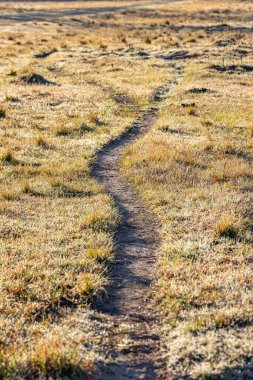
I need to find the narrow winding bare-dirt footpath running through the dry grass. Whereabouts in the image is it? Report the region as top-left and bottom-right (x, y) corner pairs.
(93, 67), (182, 380)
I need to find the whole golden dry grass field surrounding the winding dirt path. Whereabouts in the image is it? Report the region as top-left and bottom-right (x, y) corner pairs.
(0, 0), (253, 379)
